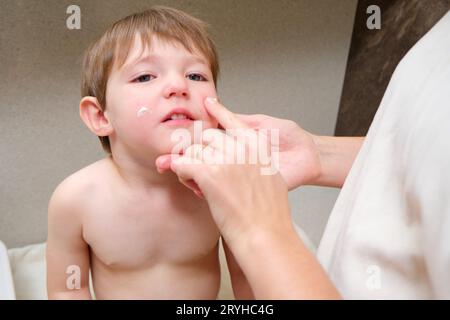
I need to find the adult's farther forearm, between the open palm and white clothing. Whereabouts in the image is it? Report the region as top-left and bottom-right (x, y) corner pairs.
(313, 136), (365, 188)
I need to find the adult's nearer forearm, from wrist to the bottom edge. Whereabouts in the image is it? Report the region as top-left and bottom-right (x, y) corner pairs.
(236, 232), (340, 299)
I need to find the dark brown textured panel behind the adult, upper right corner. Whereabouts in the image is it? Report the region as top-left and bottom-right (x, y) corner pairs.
(335, 0), (450, 136)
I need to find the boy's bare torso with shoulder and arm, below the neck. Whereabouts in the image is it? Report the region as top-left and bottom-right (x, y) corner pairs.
(47, 158), (220, 299)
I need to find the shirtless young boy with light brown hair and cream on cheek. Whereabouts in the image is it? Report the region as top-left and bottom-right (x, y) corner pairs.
(46, 7), (251, 299)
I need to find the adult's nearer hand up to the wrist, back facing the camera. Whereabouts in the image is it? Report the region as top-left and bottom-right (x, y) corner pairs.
(156, 97), (292, 246)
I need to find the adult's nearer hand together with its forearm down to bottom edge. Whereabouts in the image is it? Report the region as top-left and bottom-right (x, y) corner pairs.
(156, 97), (339, 299)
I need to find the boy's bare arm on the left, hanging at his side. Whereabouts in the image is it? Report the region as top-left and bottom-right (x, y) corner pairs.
(46, 183), (91, 300)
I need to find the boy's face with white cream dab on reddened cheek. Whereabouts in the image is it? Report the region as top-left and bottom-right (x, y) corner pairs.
(106, 36), (217, 155)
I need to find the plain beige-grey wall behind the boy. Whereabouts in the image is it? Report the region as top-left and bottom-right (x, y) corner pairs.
(0, 0), (357, 248)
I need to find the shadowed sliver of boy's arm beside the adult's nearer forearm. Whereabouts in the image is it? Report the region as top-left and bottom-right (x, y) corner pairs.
(222, 238), (255, 300)
